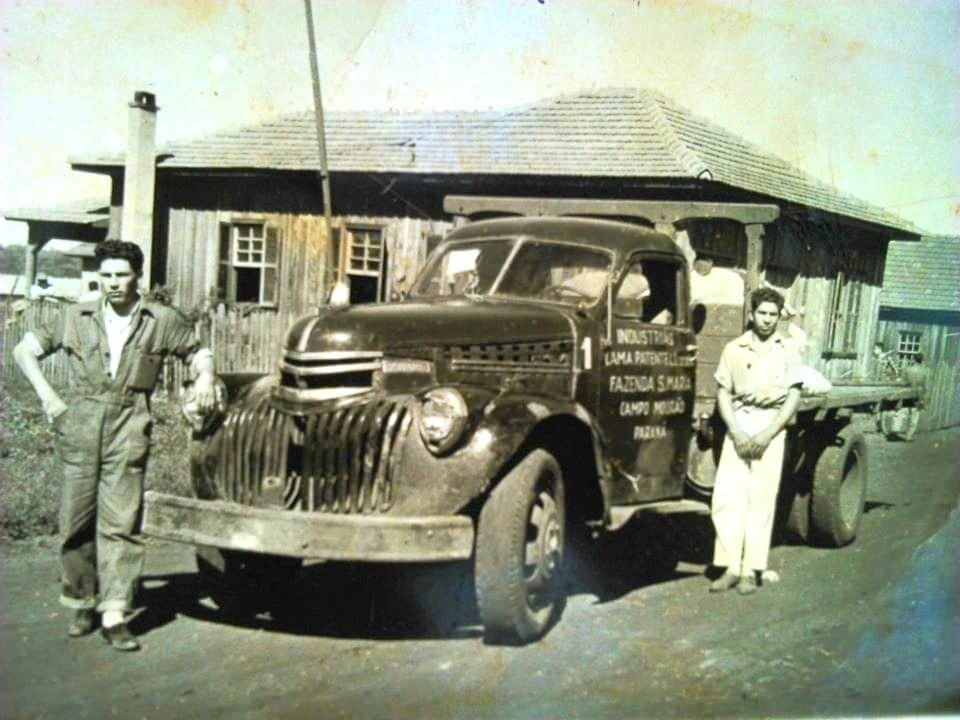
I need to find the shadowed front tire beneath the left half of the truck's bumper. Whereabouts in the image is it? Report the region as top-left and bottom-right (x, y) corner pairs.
(197, 547), (303, 617)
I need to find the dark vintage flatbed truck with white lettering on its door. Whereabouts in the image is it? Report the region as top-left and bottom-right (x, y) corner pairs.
(144, 203), (915, 643)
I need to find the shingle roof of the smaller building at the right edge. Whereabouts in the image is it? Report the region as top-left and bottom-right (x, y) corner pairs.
(880, 236), (960, 312)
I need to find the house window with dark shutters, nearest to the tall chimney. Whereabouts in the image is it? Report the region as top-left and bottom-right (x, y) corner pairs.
(217, 223), (280, 306)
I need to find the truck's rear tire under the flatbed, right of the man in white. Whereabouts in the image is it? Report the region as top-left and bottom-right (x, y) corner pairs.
(810, 425), (867, 547)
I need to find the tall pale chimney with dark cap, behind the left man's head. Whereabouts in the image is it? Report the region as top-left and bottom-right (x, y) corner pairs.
(120, 90), (158, 290)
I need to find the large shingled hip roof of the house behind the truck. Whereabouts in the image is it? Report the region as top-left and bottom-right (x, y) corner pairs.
(72, 88), (917, 234)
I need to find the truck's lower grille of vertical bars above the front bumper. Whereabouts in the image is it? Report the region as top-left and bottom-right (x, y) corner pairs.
(216, 399), (412, 513)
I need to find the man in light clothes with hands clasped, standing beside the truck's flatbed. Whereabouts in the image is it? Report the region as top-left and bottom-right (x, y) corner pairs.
(710, 288), (802, 595)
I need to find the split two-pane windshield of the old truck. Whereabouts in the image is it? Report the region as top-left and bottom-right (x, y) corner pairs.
(410, 238), (613, 305)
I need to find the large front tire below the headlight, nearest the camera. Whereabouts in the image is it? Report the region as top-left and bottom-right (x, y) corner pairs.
(475, 449), (566, 644)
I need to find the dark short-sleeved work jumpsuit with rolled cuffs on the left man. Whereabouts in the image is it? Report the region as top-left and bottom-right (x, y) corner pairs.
(33, 300), (197, 612)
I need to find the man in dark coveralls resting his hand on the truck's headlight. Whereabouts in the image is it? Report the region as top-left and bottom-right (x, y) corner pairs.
(14, 240), (218, 650)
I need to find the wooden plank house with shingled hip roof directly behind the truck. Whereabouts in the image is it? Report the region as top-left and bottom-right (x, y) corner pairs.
(63, 89), (918, 379)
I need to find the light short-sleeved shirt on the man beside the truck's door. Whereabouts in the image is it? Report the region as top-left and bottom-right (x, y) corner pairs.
(714, 330), (803, 408)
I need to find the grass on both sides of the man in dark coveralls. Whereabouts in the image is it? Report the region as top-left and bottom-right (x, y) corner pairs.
(0, 381), (190, 540)
